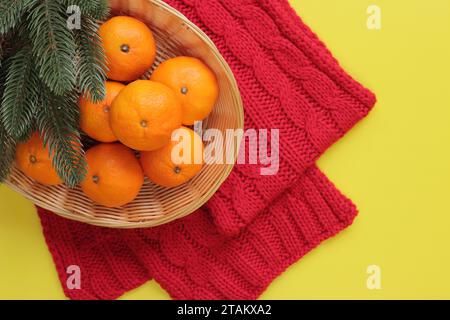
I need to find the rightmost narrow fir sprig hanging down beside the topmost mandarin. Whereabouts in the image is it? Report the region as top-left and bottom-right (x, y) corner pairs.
(75, 17), (107, 102)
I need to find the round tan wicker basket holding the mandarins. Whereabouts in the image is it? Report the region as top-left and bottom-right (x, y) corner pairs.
(6, 0), (243, 228)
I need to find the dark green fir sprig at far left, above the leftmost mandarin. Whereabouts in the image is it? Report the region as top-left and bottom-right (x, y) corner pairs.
(0, 47), (39, 141)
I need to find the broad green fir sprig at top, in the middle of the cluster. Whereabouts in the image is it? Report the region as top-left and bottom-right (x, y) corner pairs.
(28, 0), (76, 95)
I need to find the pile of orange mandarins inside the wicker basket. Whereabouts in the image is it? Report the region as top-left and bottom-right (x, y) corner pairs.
(16, 16), (219, 207)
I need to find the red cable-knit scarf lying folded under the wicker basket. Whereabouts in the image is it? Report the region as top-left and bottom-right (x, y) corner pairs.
(39, 0), (375, 299)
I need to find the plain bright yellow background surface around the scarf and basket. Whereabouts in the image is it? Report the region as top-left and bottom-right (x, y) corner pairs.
(0, 0), (450, 299)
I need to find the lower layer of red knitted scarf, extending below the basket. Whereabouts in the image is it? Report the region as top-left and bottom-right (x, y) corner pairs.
(39, 167), (356, 299)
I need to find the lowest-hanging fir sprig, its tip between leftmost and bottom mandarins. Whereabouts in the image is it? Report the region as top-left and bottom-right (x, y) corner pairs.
(36, 87), (86, 188)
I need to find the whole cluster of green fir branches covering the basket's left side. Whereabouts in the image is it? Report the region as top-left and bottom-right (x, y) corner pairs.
(0, 0), (109, 187)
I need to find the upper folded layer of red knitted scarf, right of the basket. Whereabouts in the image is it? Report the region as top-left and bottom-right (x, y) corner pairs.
(169, 0), (375, 234)
